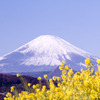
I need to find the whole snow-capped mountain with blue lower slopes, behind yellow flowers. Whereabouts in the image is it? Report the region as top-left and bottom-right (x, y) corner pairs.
(0, 35), (98, 77)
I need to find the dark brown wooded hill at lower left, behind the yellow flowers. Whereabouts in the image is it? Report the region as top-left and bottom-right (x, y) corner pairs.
(0, 74), (47, 100)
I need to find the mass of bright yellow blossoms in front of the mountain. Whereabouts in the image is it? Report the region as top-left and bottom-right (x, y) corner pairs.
(4, 58), (100, 100)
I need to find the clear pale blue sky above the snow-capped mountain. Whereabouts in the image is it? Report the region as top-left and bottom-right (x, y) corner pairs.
(0, 0), (100, 57)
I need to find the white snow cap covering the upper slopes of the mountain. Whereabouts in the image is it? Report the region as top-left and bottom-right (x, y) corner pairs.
(15, 35), (95, 66)
